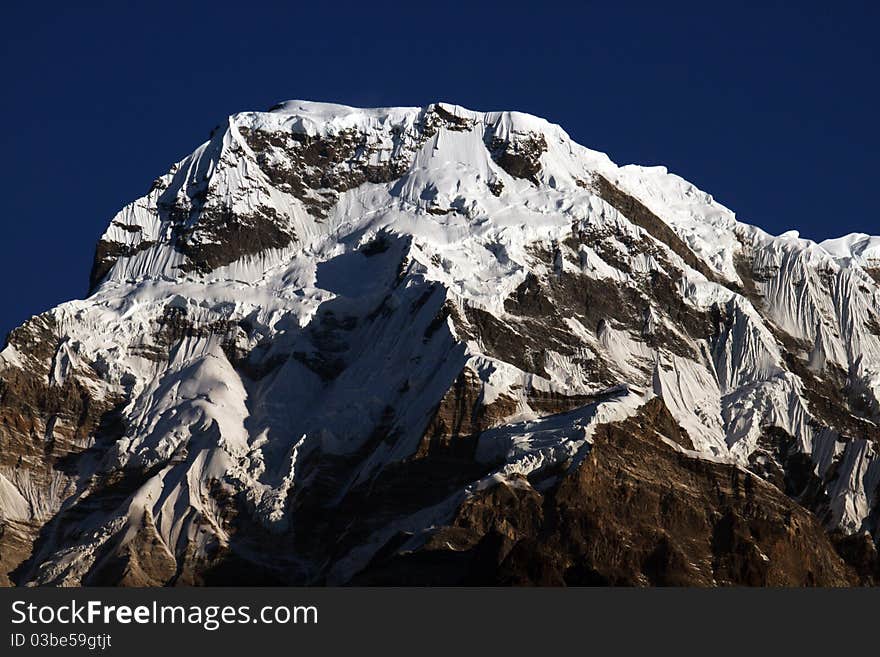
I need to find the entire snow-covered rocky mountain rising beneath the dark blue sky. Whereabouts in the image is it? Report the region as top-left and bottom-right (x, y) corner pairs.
(0, 101), (880, 585)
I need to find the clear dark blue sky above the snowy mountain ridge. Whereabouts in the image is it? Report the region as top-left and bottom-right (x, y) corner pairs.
(0, 0), (880, 335)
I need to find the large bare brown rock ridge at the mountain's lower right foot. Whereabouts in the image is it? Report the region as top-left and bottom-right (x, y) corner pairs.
(357, 399), (858, 586)
